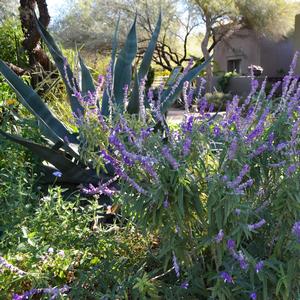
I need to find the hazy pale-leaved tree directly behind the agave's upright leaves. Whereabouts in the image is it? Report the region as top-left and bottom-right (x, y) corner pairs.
(54, 0), (198, 70)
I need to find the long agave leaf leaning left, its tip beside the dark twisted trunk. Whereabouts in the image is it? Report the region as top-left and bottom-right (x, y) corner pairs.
(35, 18), (83, 115)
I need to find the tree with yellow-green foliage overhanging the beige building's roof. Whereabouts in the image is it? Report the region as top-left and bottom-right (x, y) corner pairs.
(188, 0), (295, 92)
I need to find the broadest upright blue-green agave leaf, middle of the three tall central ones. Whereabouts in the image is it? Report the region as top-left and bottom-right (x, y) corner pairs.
(113, 16), (137, 109)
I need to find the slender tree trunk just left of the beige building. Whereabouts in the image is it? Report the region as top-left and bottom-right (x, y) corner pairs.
(201, 15), (213, 93)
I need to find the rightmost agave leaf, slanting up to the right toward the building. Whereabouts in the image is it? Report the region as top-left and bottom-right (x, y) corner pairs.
(161, 57), (212, 113)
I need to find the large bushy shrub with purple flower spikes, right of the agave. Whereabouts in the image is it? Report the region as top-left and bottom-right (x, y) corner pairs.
(79, 55), (300, 299)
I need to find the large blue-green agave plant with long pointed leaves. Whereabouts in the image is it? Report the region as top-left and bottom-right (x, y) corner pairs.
(0, 14), (207, 185)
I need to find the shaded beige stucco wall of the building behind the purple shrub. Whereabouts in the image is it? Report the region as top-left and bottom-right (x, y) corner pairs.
(214, 15), (300, 77)
